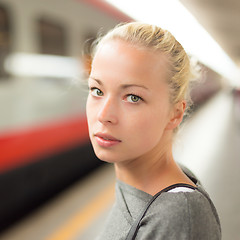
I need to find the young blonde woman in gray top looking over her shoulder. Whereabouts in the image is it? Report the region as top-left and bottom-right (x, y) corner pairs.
(87, 22), (221, 240)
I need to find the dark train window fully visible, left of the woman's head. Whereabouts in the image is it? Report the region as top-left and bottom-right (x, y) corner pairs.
(37, 18), (66, 56)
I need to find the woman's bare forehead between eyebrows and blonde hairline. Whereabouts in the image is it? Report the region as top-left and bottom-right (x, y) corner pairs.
(91, 40), (167, 89)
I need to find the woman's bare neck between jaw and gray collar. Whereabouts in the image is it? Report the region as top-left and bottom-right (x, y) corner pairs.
(115, 135), (194, 195)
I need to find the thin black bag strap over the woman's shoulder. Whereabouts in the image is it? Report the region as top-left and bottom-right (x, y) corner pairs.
(126, 183), (196, 240)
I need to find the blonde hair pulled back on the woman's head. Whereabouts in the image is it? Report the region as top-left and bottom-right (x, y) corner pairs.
(93, 22), (197, 110)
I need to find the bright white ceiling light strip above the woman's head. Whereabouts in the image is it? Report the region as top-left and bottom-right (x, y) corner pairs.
(106, 0), (240, 86)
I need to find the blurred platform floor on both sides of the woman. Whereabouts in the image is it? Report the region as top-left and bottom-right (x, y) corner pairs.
(0, 92), (240, 240)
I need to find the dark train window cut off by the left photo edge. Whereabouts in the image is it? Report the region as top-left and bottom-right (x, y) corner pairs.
(0, 6), (11, 78)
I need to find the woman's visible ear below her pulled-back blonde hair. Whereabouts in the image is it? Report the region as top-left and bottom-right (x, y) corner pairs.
(166, 100), (187, 130)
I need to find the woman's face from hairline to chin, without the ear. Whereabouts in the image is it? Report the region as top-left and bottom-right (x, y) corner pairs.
(86, 40), (171, 163)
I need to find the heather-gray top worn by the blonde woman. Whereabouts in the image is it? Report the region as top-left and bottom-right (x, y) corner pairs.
(97, 169), (221, 240)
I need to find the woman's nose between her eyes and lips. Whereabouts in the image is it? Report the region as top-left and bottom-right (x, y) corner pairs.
(98, 98), (118, 124)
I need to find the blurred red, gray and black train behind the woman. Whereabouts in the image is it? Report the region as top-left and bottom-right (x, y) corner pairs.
(0, 0), (221, 230)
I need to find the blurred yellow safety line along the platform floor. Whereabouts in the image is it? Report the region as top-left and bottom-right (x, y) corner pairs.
(45, 184), (114, 240)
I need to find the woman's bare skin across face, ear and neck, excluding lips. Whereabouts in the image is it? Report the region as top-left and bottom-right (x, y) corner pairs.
(86, 40), (194, 195)
